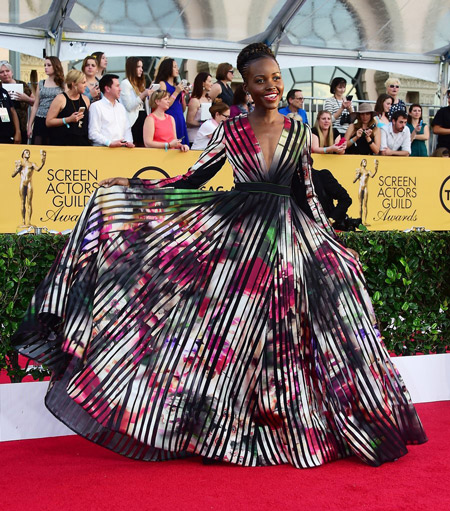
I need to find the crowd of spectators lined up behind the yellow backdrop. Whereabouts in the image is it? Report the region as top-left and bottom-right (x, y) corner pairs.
(0, 52), (450, 156)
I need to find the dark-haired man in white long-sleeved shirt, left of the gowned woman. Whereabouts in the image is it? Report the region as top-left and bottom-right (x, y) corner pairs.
(89, 74), (134, 147)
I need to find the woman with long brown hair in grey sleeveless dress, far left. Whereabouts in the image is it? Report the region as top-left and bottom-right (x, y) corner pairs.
(27, 56), (64, 144)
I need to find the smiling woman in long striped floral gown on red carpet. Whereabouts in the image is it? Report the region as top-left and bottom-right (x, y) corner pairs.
(16, 44), (426, 467)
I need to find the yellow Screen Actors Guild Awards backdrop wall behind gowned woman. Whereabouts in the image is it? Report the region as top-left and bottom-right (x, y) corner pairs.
(0, 145), (450, 233)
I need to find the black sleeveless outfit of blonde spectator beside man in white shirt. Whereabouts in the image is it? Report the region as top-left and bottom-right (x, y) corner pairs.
(48, 92), (91, 146)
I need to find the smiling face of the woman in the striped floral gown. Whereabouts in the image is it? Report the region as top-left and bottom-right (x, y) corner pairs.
(245, 57), (284, 110)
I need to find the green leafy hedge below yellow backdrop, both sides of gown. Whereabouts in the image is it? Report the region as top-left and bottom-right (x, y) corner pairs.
(0, 231), (450, 381)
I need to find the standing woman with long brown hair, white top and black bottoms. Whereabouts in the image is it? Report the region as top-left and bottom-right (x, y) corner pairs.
(120, 57), (151, 147)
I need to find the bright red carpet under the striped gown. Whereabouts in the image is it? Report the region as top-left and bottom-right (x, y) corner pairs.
(0, 401), (450, 511)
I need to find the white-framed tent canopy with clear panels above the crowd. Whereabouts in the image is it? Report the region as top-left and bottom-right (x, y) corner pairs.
(0, 0), (450, 87)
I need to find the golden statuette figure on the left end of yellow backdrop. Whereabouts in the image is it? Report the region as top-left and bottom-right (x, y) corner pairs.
(12, 149), (47, 229)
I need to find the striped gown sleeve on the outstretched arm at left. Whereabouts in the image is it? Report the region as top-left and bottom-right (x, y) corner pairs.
(130, 124), (226, 189)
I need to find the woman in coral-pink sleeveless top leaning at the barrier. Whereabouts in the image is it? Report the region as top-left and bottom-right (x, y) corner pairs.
(144, 90), (189, 152)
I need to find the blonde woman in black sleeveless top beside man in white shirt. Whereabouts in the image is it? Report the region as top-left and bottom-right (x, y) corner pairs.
(45, 69), (91, 146)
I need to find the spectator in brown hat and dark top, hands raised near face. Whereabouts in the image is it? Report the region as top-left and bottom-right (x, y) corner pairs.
(345, 103), (381, 155)
